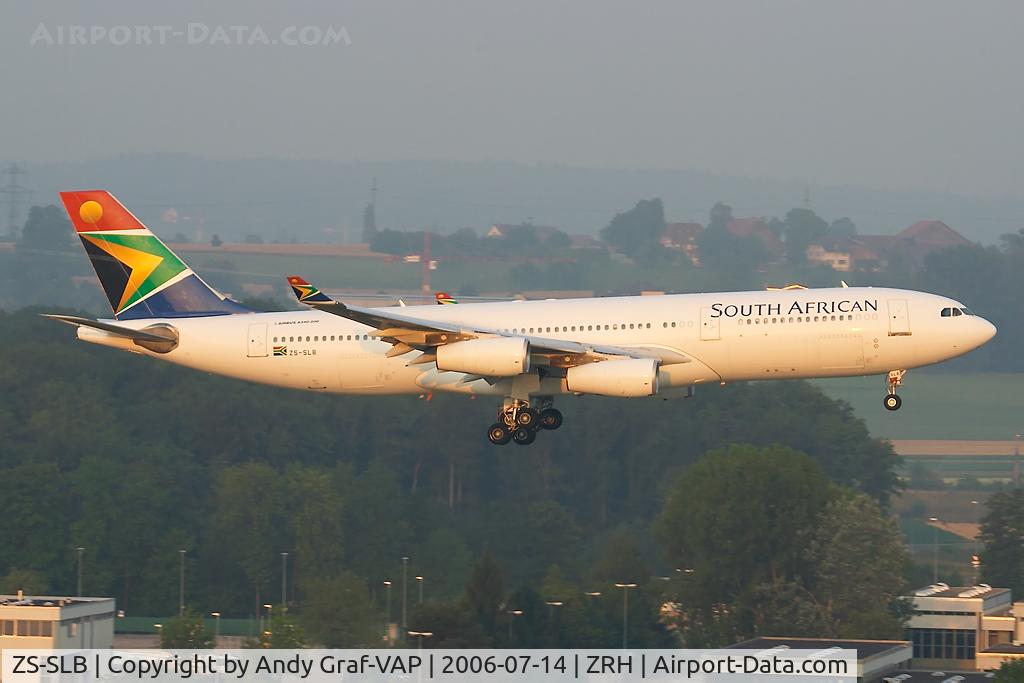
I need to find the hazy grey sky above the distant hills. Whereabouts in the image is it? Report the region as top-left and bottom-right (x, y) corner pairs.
(0, 0), (1024, 196)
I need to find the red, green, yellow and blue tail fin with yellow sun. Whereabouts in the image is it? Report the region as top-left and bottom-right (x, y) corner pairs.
(60, 189), (250, 319)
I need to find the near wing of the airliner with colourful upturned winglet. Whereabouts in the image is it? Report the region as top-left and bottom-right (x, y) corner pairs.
(288, 275), (690, 368)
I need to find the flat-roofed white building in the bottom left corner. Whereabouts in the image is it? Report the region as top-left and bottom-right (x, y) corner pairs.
(0, 594), (116, 651)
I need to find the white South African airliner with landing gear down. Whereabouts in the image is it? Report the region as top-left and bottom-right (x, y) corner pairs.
(49, 190), (995, 444)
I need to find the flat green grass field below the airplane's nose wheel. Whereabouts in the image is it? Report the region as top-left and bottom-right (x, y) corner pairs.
(815, 371), (1024, 440)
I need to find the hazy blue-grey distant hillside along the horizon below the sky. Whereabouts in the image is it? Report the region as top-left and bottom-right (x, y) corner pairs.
(9, 155), (1024, 242)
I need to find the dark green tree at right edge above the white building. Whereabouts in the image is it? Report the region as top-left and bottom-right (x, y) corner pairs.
(981, 488), (1024, 595)
